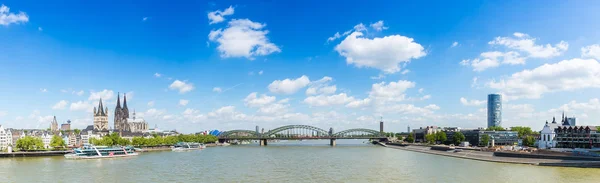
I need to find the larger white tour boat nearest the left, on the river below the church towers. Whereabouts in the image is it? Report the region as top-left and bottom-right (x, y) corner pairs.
(65, 144), (138, 159)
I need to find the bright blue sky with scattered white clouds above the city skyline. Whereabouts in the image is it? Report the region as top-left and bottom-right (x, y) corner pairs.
(0, 0), (600, 132)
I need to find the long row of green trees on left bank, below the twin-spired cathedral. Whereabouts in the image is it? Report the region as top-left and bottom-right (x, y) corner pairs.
(90, 133), (218, 146)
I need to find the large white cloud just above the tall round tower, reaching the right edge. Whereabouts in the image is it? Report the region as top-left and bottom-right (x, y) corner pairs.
(487, 59), (600, 99)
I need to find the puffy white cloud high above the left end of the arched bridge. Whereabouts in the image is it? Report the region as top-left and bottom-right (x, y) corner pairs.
(208, 19), (281, 60)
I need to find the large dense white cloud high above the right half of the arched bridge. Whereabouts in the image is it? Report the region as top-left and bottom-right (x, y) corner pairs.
(335, 32), (426, 73)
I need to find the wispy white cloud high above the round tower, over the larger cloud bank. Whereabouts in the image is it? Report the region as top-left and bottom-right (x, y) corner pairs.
(488, 32), (569, 58)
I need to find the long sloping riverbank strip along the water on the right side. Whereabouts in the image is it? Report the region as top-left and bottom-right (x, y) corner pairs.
(387, 145), (600, 168)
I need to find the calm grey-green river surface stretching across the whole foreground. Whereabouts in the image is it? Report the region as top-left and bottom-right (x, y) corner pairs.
(0, 140), (600, 183)
